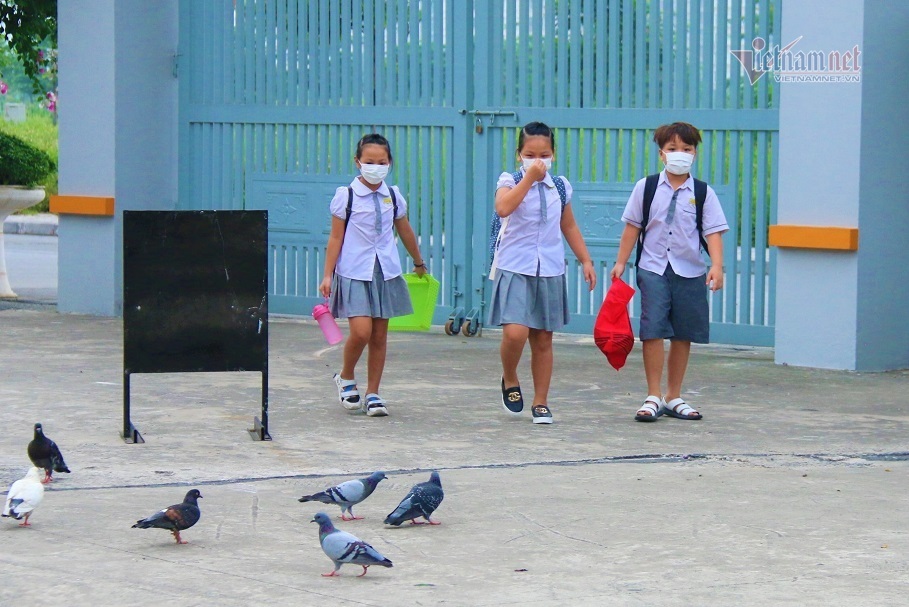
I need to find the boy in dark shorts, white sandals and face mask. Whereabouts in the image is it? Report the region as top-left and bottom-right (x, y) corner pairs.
(611, 122), (729, 422)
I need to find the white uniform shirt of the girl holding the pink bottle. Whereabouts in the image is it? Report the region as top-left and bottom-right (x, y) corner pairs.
(329, 178), (407, 281)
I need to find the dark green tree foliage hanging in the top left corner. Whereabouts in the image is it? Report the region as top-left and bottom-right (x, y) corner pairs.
(0, 0), (57, 93)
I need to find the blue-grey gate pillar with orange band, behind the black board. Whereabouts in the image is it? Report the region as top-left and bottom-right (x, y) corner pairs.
(51, 0), (178, 316)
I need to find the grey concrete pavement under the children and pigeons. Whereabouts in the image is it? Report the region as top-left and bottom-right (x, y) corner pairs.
(0, 309), (909, 606)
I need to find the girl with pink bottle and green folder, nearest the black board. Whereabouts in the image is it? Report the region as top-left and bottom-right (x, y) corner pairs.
(319, 133), (426, 417)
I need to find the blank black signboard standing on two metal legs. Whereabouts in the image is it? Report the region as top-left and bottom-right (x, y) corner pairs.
(122, 211), (271, 442)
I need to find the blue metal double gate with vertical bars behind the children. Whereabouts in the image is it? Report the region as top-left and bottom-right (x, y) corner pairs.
(179, 0), (780, 345)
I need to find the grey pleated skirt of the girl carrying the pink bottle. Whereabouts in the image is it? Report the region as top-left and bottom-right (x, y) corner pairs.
(328, 258), (413, 318)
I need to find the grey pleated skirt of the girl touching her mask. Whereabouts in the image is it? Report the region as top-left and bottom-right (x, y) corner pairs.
(487, 270), (568, 331)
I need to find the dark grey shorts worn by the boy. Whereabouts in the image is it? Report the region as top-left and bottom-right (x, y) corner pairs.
(637, 263), (710, 344)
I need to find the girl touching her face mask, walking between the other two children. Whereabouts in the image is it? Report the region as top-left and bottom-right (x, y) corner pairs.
(488, 122), (597, 424)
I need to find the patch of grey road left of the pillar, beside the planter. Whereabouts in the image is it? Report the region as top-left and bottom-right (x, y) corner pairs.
(3, 234), (57, 301)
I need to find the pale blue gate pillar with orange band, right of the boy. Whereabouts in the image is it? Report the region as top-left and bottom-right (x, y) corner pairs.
(765, 0), (909, 371)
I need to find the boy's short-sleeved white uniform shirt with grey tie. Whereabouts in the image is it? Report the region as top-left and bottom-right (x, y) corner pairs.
(622, 169), (729, 278)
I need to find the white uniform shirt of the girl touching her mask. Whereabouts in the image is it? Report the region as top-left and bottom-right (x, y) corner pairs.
(496, 172), (572, 277)
